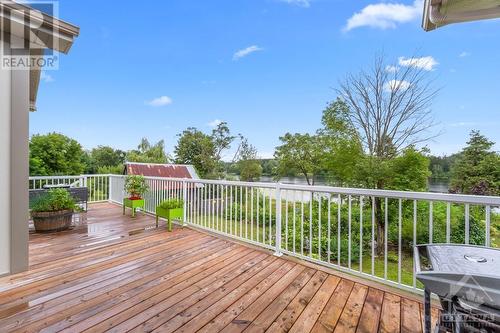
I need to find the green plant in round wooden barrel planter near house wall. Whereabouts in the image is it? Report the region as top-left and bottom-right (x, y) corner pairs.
(31, 188), (77, 232)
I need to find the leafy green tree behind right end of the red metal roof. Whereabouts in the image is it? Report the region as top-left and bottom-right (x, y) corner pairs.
(174, 127), (218, 178)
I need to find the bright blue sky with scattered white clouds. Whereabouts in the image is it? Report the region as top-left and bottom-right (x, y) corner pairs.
(30, 0), (500, 158)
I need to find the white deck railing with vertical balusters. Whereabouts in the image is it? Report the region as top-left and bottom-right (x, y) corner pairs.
(30, 175), (500, 291)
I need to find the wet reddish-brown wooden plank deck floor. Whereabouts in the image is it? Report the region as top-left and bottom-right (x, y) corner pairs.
(0, 203), (436, 333)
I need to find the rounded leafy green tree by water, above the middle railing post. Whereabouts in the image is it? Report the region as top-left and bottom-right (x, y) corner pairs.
(274, 133), (324, 185)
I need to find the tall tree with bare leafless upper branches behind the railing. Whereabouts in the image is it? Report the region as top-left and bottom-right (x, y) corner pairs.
(336, 53), (438, 253)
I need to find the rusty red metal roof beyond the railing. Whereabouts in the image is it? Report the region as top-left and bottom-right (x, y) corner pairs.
(125, 162), (198, 179)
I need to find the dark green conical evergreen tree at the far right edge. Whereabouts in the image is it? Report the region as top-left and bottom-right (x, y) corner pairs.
(451, 131), (500, 195)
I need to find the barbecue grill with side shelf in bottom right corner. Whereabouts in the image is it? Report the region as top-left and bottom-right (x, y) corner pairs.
(415, 244), (500, 333)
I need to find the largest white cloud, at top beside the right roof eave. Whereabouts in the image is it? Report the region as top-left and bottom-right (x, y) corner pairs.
(343, 0), (424, 32)
